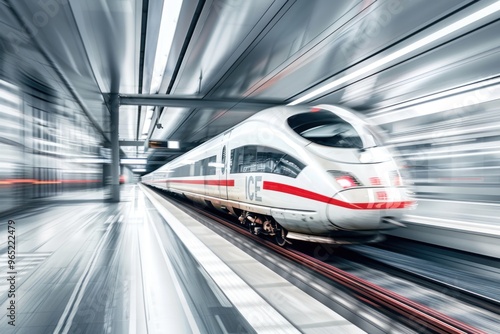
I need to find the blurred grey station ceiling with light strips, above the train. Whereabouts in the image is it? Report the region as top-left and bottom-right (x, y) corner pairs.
(0, 0), (500, 169)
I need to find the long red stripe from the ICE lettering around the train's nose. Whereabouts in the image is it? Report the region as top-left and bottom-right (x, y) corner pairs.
(262, 181), (414, 210)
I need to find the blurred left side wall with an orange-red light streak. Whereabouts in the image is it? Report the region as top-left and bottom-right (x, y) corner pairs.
(0, 80), (114, 212)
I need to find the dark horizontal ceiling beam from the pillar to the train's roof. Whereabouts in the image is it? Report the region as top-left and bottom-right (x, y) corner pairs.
(120, 94), (284, 110)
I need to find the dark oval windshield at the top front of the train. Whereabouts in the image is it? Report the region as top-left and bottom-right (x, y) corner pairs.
(288, 110), (381, 149)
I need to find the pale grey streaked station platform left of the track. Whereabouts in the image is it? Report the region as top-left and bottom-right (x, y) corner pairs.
(0, 185), (363, 333)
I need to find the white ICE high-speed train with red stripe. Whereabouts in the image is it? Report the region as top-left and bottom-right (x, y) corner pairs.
(142, 105), (415, 246)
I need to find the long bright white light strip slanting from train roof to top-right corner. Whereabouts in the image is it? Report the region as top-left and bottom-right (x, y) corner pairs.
(288, 1), (500, 106)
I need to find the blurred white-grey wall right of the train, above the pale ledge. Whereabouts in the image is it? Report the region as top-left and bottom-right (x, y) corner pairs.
(372, 78), (500, 203)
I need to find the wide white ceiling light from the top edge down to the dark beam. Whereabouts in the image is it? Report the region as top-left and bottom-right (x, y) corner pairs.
(149, 0), (186, 94)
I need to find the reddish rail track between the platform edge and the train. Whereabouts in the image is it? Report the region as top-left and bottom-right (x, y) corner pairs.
(150, 189), (489, 333)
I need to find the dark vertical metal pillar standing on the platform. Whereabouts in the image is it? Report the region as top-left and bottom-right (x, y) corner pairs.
(109, 93), (120, 202)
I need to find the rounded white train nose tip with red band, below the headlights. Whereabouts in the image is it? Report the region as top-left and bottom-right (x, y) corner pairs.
(327, 188), (414, 231)
